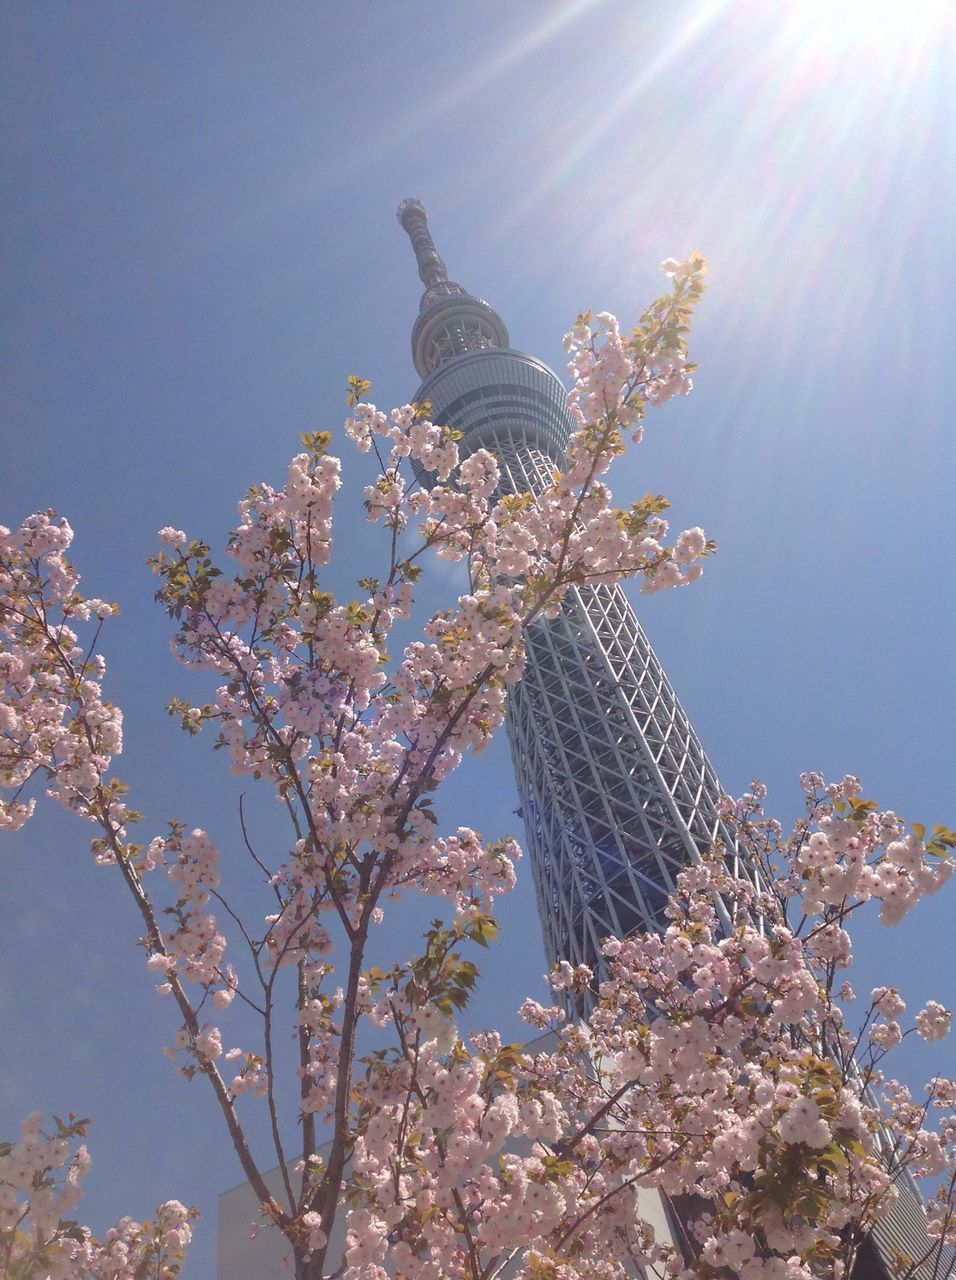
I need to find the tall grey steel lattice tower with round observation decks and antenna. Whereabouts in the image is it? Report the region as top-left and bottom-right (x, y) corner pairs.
(398, 200), (735, 972)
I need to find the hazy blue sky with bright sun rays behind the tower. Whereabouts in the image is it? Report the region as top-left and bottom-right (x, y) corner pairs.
(0, 0), (956, 1280)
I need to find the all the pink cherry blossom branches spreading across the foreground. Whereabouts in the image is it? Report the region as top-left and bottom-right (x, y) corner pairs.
(0, 255), (956, 1280)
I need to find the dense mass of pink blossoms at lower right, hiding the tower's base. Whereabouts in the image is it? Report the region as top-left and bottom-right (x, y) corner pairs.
(327, 795), (956, 1280)
